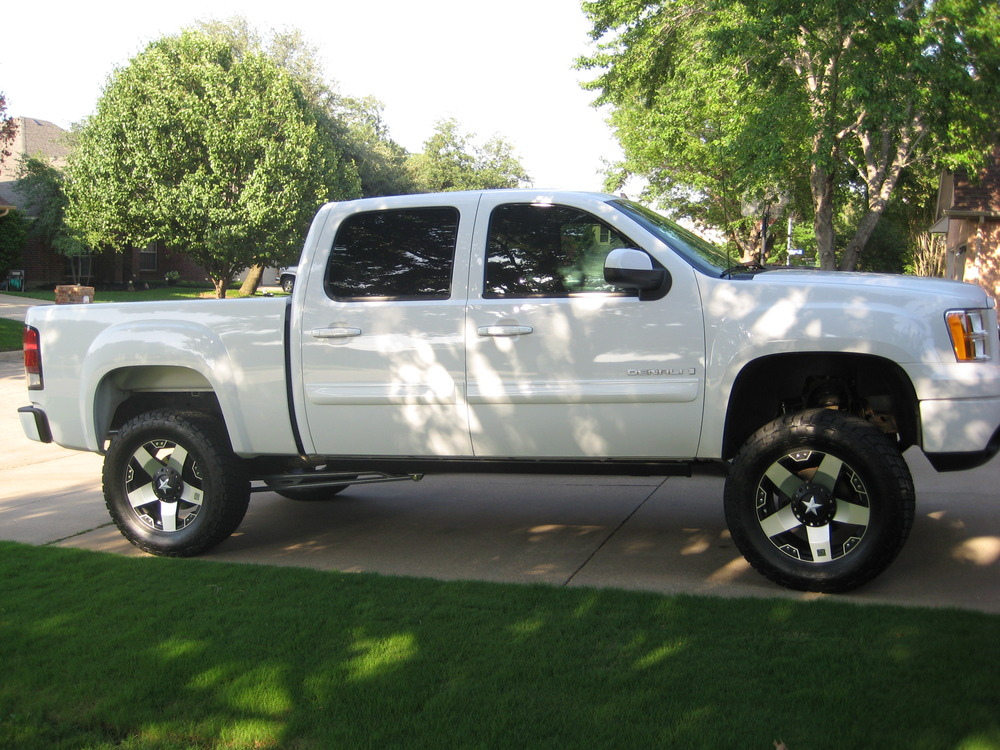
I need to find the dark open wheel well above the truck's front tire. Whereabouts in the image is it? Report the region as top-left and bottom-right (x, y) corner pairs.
(722, 352), (920, 459)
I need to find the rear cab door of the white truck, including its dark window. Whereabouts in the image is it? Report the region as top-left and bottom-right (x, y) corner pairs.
(293, 194), (478, 456)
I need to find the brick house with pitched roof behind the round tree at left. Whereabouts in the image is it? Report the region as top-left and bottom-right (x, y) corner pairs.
(0, 117), (207, 287)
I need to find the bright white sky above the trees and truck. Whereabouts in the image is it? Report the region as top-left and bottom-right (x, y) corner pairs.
(0, 0), (621, 190)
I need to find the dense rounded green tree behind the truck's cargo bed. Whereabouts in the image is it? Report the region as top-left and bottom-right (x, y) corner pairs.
(66, 31), (358, 297)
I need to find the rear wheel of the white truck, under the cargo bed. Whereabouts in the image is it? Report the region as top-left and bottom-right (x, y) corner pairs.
(104, 411), (250, 557)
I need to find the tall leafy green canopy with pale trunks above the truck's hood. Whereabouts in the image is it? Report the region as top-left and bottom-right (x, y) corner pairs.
(581, 0), (1000, 268)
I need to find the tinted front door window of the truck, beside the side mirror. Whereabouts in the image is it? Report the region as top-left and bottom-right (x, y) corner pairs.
(483, 203), (636, 297)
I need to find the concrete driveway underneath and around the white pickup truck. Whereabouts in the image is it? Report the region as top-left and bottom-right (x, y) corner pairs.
(0, 295), (1000, 613)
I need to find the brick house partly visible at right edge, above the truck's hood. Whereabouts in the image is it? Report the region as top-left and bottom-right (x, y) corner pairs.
(930, 146), (1000, 304)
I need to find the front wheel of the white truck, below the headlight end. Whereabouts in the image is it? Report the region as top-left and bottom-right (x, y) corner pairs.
(725, 409), (915, 592)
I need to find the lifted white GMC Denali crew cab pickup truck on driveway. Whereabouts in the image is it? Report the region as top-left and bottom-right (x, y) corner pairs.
(20, 191), (1000, 591)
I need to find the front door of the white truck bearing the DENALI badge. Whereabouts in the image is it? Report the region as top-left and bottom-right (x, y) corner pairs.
(466, 193), (705, 458)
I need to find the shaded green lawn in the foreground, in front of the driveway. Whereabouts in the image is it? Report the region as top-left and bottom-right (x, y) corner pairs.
(0, 542), (1000, 750)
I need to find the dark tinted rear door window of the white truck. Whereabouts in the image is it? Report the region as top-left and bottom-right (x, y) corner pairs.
(325, 206), (459, 300)
